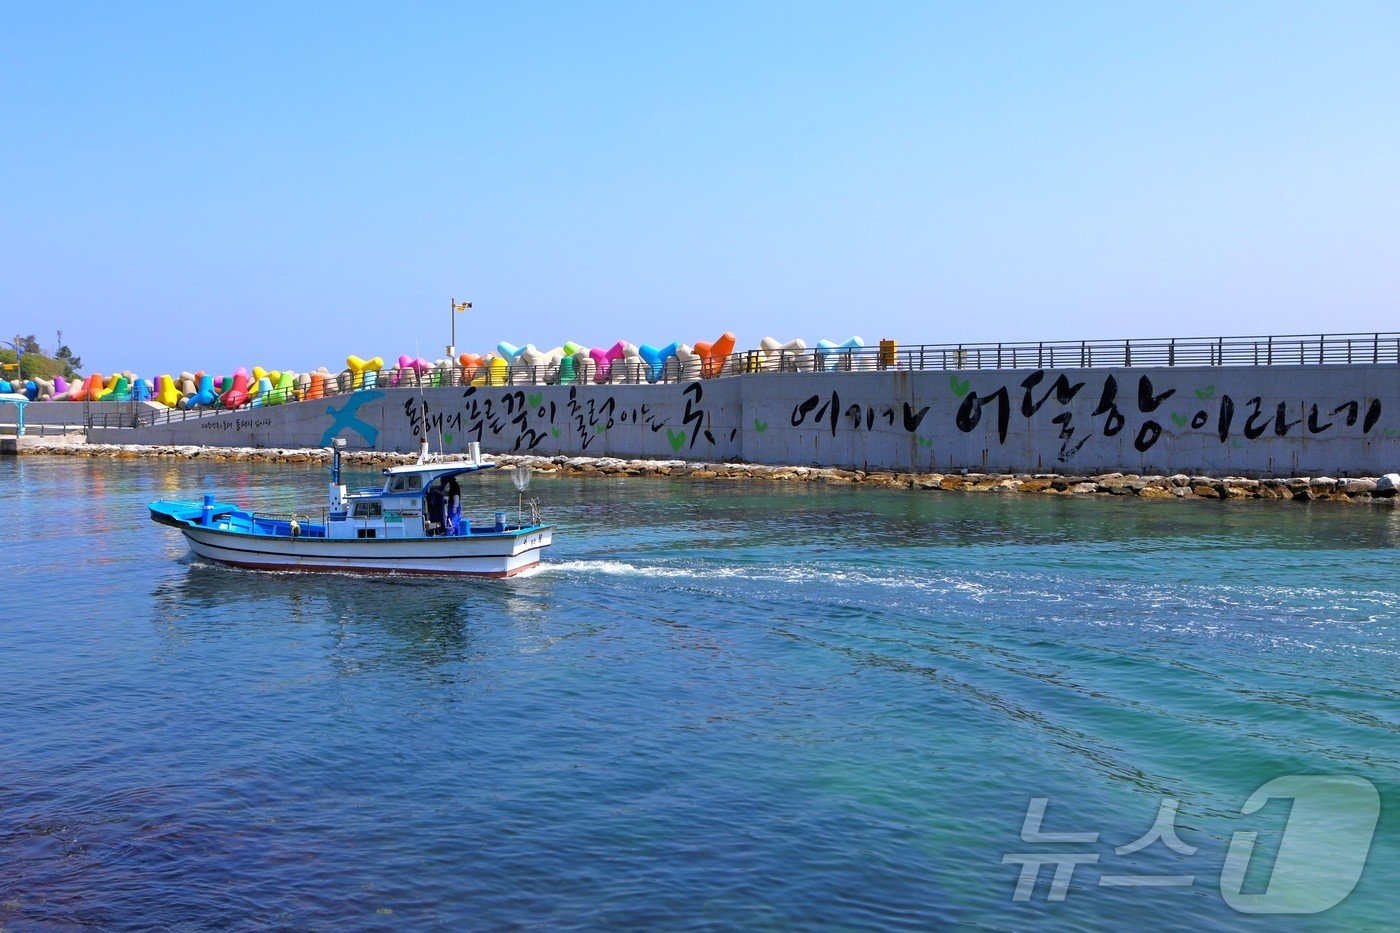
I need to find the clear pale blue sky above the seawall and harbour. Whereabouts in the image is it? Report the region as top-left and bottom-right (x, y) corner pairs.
(0, 0), (1400, 375)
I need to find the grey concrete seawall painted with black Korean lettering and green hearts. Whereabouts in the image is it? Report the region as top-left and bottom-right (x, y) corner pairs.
(65, 364), (1400, 476)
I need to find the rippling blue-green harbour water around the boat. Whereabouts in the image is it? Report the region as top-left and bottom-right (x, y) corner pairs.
(0, 458), (1400, 929)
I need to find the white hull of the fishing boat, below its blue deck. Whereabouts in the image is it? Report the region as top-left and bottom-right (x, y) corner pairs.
(181, 525), (553, 577)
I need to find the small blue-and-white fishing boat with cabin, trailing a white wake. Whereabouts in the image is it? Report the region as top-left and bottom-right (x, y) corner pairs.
(150, 441), (554, 577)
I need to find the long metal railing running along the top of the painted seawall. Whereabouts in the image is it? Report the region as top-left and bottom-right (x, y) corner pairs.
(76, 332), (1400, 427)
